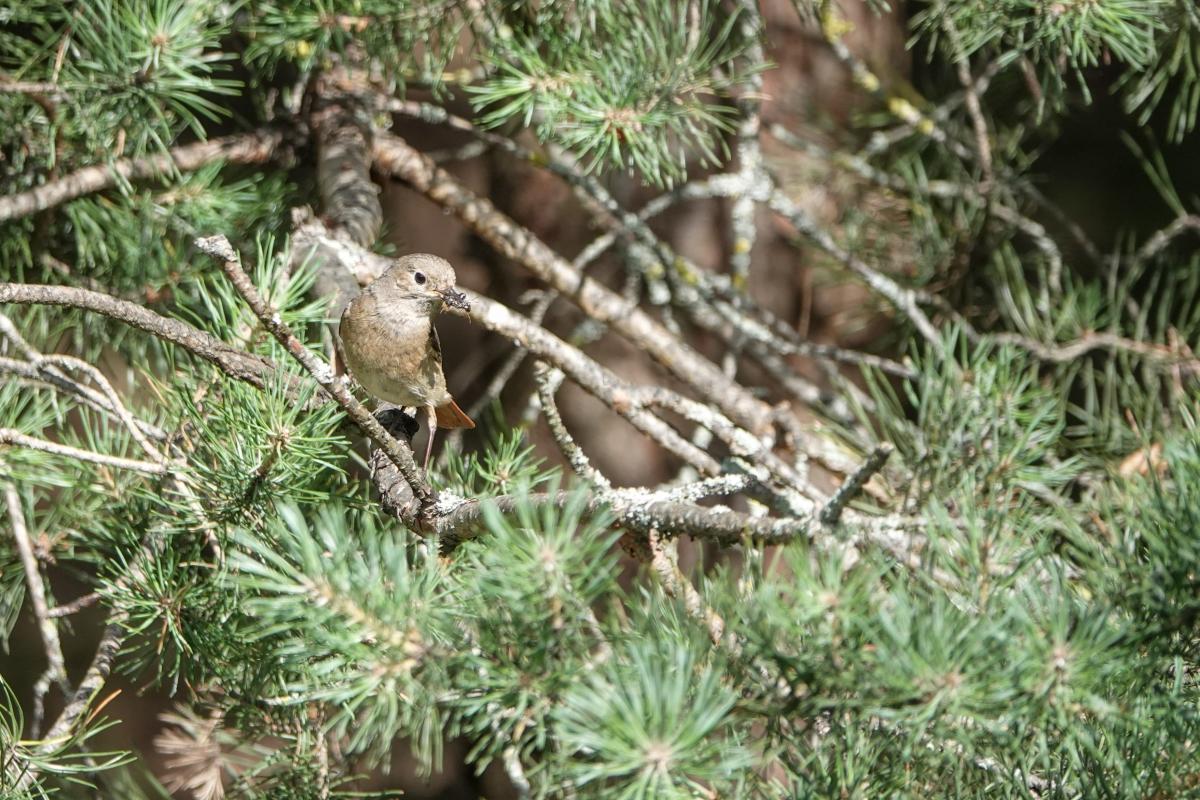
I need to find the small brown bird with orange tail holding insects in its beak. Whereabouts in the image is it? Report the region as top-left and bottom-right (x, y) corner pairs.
(337, 253), (475, 469)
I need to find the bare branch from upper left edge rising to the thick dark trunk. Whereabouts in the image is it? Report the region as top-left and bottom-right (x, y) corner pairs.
(0, 128), (283, 222)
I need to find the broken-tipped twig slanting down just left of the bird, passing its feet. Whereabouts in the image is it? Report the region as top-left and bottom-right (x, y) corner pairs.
(196, 235), (437, 523)
